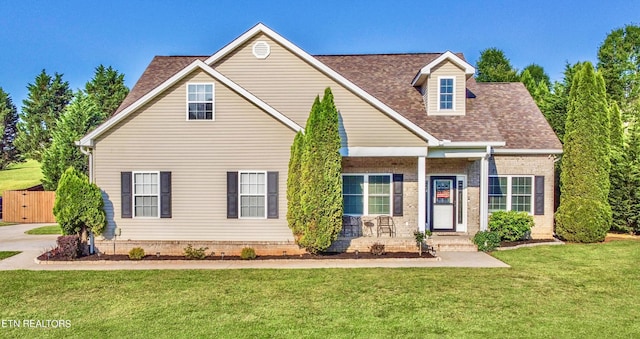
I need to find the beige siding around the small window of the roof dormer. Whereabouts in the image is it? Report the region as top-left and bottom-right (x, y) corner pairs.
(426, 60), (466, 115)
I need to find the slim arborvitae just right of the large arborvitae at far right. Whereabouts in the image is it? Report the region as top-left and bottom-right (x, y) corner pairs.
(609, 102), (634, 232)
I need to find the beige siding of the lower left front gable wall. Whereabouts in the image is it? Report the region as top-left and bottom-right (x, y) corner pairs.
(94, 71), (294, 241)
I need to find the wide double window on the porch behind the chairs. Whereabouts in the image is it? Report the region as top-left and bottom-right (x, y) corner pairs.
(342, 174), (392, 215)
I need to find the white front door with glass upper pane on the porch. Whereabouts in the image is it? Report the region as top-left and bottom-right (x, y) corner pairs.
(430, 177), (456, 231)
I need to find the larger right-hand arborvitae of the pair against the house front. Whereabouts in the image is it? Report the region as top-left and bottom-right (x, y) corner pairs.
(298, 88), (343, 253)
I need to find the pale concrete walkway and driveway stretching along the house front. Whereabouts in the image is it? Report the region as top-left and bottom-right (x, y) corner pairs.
(0, 224), (509, 271)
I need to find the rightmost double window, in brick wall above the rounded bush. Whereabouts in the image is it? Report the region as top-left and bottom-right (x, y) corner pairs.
(489, 175), (533, 213)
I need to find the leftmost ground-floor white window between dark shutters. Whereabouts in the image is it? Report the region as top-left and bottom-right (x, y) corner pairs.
(133, 172), (160, 218)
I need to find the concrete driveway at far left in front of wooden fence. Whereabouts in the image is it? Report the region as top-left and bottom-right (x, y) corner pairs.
(0, 223), (58, 270)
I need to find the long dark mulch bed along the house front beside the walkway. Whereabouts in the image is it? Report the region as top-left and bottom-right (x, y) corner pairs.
(38, 252), (435, 261)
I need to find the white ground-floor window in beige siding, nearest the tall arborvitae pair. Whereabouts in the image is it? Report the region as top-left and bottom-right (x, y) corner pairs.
(240, 172), (267, 218)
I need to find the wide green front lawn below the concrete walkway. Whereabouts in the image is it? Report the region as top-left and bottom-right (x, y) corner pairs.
(0, 241), (640, 338)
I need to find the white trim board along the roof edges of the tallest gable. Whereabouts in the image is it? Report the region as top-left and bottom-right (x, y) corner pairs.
(205, 23), (440, 145)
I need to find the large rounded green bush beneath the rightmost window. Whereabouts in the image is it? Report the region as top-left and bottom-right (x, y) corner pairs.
(489, 211), (533, 241)
